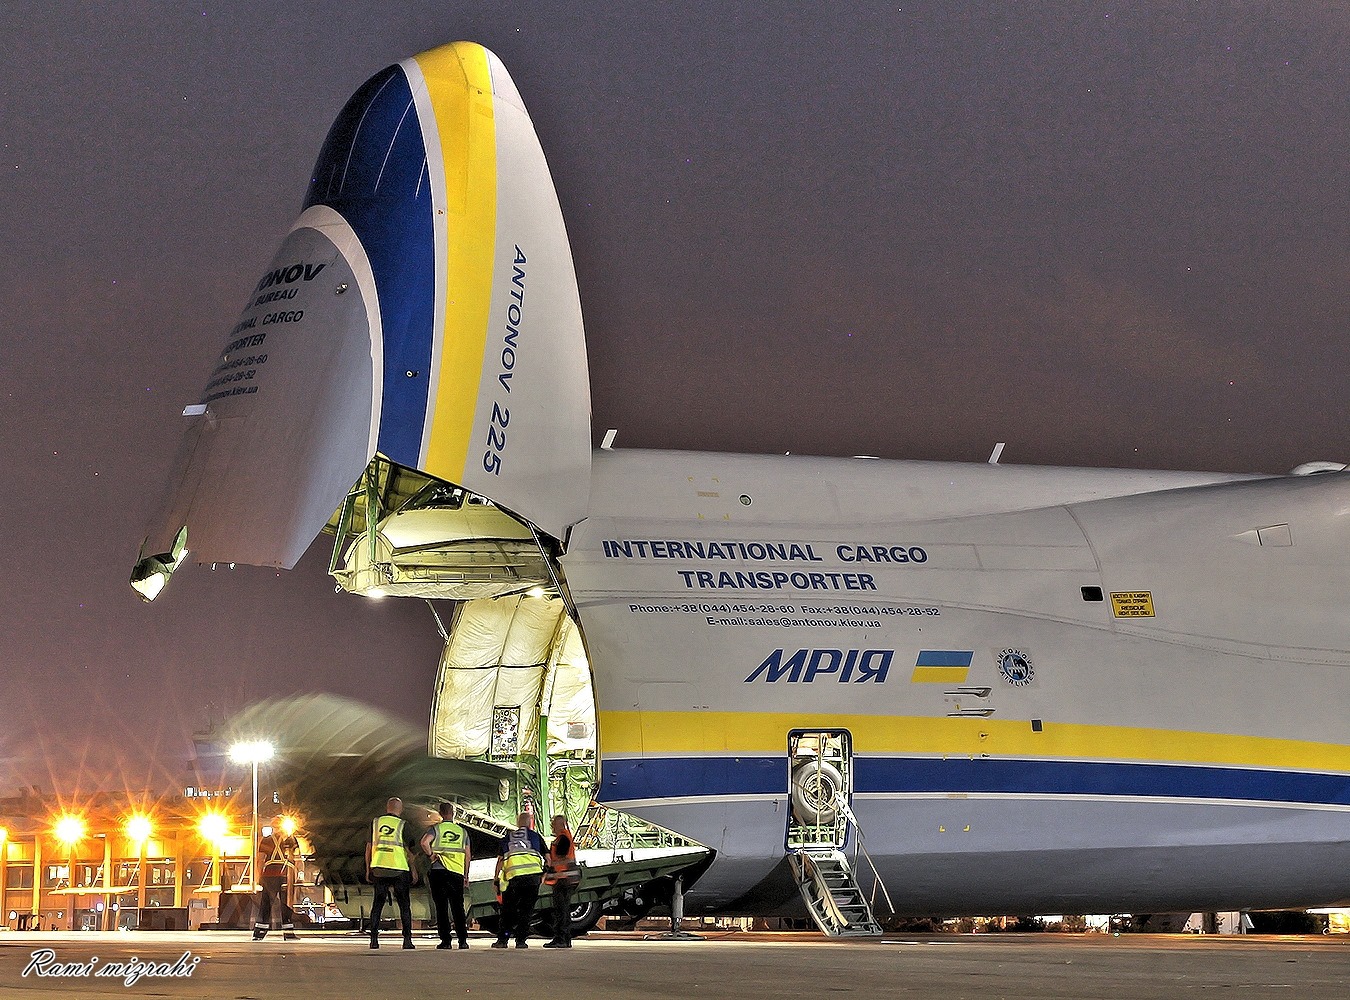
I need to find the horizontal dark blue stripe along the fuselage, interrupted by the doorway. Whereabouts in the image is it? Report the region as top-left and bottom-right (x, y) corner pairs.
(601, 756), (1350, 806)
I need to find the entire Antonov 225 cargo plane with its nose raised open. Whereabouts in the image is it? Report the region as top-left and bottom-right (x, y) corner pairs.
(132, 42), (1350, 933)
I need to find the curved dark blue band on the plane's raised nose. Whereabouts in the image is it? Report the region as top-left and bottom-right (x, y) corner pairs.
(305, 66), (436, 467)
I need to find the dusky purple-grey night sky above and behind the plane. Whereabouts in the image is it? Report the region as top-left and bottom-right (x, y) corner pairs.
(0, 1), (1350, 794)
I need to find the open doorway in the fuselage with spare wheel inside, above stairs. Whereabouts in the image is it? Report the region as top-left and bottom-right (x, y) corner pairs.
(787, 729), (853, 850)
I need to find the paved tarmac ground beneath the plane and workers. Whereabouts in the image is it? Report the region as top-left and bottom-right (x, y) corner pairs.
(0, 931), (1350, 1000)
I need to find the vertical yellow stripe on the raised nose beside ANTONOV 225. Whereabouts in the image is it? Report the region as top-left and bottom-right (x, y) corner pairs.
(416, 42), (497, 482)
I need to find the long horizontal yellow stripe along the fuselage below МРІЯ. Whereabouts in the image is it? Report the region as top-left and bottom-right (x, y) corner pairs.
(599, 711), (1350, 772)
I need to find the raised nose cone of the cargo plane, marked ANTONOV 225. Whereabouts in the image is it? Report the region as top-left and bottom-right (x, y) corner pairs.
(132, 42), (591, 599)
